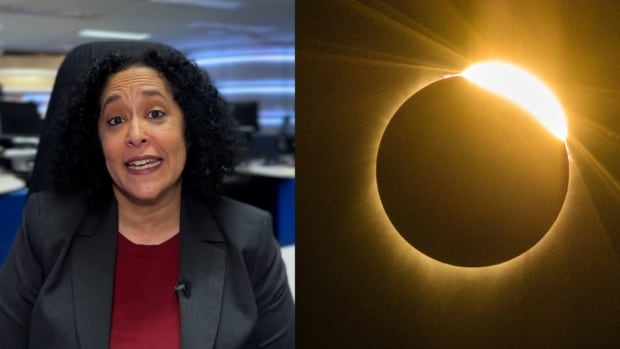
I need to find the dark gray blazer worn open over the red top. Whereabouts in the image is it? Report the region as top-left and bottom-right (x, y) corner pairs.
(0, 192), (295, 349)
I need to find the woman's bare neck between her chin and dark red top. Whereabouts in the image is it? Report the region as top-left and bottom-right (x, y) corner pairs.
(115, 191), (181, 245)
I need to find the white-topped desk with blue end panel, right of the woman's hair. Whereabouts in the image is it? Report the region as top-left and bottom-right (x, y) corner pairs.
(224, 163), (295, 246)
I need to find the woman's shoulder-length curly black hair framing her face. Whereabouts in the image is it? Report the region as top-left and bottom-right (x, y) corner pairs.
(50, 47), (238, 206)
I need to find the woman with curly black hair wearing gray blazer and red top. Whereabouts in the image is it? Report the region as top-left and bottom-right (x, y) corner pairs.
(0, 47), (294, 349)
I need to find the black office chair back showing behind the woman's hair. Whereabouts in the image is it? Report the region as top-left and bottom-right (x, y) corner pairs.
(28, 41), (172, 194)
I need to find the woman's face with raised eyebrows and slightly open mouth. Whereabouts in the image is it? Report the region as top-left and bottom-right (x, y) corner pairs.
(98, 66), (187, 203)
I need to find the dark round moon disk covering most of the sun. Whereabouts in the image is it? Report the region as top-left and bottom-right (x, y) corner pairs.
(377, 76), (569, 267)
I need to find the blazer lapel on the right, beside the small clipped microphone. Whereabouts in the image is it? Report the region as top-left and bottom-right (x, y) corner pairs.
(178, 195), (226, 349)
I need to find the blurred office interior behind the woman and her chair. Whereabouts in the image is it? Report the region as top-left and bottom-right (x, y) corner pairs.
(0, 0), (295, 294)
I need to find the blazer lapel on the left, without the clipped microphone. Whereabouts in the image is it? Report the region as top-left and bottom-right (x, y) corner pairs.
(71, 200), (118, 349)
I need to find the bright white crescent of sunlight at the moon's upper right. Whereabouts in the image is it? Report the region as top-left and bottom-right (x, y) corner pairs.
(461, 62), (568, 141)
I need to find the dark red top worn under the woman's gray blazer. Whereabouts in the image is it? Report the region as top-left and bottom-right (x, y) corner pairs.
(110, 234), (180, 349)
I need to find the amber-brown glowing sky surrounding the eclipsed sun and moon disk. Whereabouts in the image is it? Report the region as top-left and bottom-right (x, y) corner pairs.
(296, 0), (620, 348)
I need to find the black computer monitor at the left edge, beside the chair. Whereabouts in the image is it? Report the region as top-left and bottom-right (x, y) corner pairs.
(0, 101), (43, 139)
